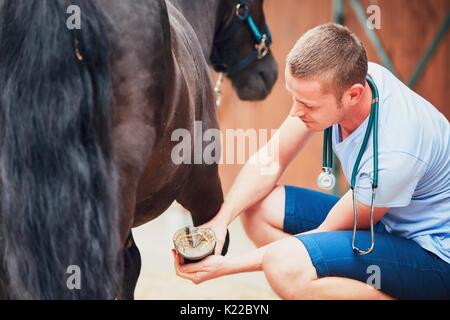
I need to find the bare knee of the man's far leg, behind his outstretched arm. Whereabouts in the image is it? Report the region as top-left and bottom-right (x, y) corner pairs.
(241, 186), (290, 248)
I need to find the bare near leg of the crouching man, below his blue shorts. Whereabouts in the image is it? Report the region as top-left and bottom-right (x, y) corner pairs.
(263, 237), (392, 299)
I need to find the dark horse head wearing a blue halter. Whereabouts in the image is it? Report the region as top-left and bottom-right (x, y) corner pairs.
(211, 0), (278, 100)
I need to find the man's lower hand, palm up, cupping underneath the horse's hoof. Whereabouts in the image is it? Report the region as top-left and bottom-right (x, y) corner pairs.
(172, 249), (226, 284)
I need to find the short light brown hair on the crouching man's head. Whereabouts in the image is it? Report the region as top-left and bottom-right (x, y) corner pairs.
(287, 23), (368, 100)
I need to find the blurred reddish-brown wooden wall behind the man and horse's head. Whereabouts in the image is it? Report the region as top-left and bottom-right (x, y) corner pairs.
(218, 0), (450, 191)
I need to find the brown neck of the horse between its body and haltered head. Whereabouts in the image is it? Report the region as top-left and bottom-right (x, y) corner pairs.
(166, 0), (221, 60)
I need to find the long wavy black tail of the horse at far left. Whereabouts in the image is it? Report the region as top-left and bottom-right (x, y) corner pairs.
(0, 0), (121, 299)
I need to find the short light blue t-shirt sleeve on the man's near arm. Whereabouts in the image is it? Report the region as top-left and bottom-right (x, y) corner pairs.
(356, 152), (427, 208)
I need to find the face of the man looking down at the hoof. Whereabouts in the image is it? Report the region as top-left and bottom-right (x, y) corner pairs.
(285, 67), (345, 131)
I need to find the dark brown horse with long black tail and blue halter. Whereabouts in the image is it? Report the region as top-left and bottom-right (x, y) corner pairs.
(0, 0), (277, 299)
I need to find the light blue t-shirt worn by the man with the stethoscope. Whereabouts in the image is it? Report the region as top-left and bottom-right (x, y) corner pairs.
(333, 63), (450, 263)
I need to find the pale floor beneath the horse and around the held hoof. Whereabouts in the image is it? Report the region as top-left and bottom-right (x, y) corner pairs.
(134, 204), (278, 300)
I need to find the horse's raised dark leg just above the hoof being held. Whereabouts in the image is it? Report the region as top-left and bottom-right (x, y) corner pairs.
(177, 164), (230, 255)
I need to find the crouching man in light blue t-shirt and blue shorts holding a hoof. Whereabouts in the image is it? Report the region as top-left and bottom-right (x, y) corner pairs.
(173, 24), (450, 299)
